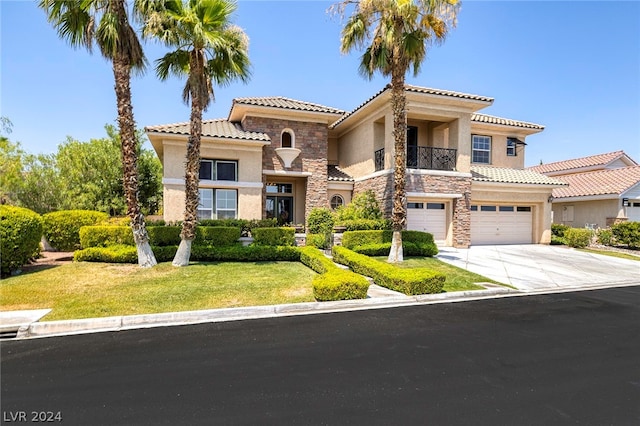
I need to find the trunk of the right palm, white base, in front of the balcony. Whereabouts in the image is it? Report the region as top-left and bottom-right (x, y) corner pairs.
(387, 67), (407, 263)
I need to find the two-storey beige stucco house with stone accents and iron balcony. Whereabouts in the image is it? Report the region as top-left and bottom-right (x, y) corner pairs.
(145, 85), (565, 247)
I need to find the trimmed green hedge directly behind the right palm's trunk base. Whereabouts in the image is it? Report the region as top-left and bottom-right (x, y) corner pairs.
(342, 230), (438, 257)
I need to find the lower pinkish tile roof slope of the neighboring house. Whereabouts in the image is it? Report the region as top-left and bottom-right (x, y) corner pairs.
(553, 166), (640, 198)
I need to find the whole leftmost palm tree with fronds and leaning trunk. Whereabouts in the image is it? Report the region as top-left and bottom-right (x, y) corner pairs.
(39, 0), (157, 267)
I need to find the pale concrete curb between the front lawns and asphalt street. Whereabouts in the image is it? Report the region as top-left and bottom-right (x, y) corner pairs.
(12, 288), (522, 340)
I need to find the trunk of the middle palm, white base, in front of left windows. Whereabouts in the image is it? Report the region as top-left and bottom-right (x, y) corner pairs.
(173, 52), (205, 266)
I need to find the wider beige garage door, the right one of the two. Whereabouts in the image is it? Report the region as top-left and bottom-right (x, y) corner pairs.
(471, 205), (533, 245)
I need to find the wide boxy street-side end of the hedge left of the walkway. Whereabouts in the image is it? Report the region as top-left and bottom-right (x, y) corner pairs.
(312, 268), (369, 302)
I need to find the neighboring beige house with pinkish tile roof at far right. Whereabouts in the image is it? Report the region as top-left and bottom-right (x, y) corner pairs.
(529, 151), (640, 228)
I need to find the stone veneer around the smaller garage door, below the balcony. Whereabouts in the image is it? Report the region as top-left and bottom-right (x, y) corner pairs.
(353, 173), (471, 248)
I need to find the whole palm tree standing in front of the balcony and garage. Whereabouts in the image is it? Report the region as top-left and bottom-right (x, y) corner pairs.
(336, 0), (458, 262)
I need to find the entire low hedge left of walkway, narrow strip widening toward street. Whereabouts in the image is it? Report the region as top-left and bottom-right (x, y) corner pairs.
(298, 246), (369, 302)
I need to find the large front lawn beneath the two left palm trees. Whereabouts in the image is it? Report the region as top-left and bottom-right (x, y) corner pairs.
(0, 262), (316, 321)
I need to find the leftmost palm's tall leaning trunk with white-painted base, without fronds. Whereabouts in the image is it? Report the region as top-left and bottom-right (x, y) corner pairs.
(113, 43), (158, 268)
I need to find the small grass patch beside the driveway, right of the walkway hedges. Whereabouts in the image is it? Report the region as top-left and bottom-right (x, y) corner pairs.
(375, 256), (504, 292)
